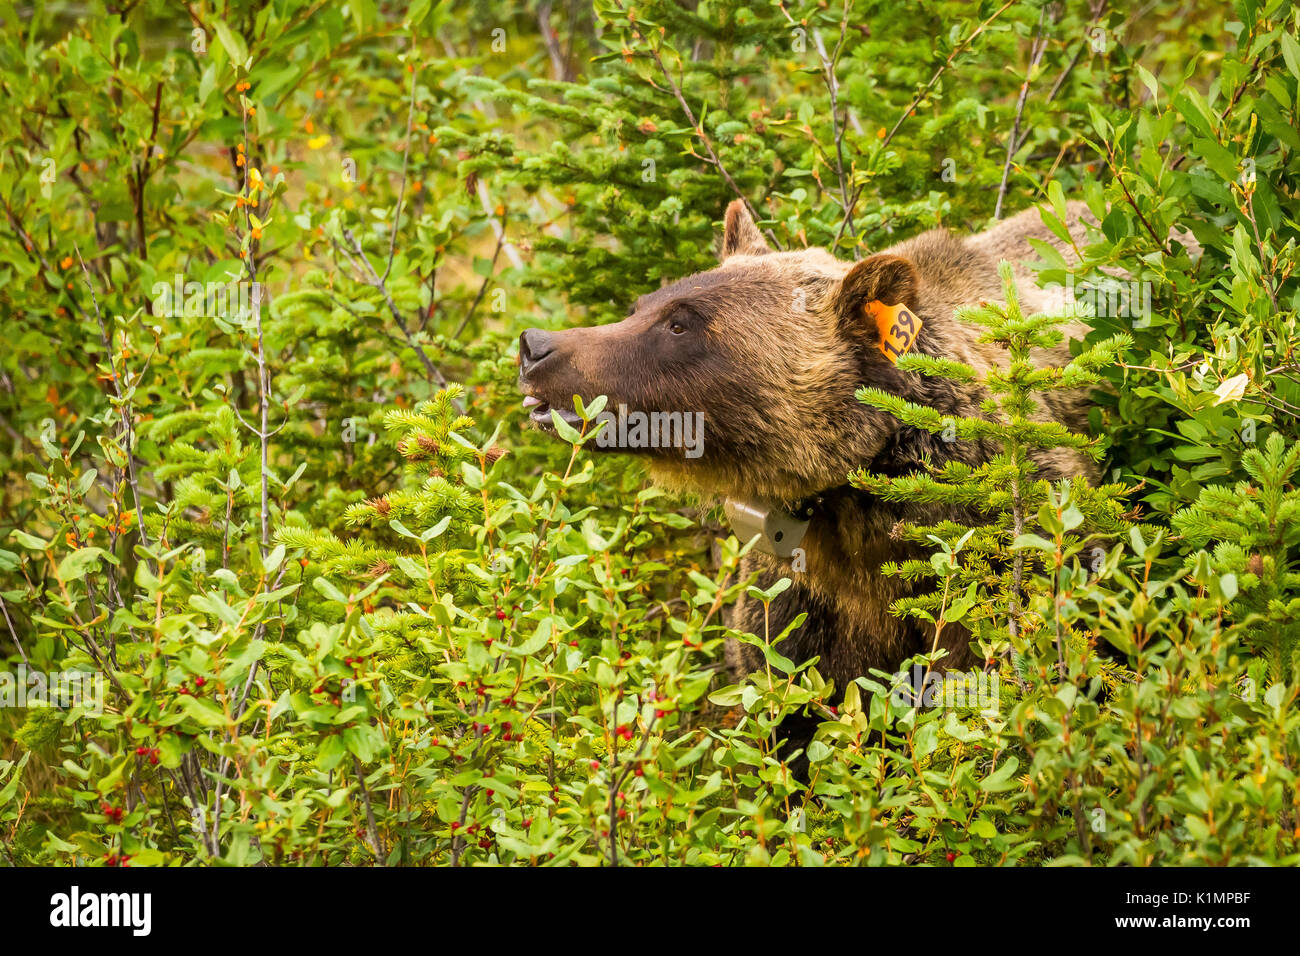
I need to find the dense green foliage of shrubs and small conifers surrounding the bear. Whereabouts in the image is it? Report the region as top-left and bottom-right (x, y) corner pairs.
(0, 0), (1300, 865)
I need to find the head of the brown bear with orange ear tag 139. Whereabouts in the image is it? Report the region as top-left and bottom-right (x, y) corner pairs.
(519, 200), (941, 502)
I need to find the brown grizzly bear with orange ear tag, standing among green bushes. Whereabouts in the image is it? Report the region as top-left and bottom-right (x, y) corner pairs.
(519, 200), (1092, 770)
